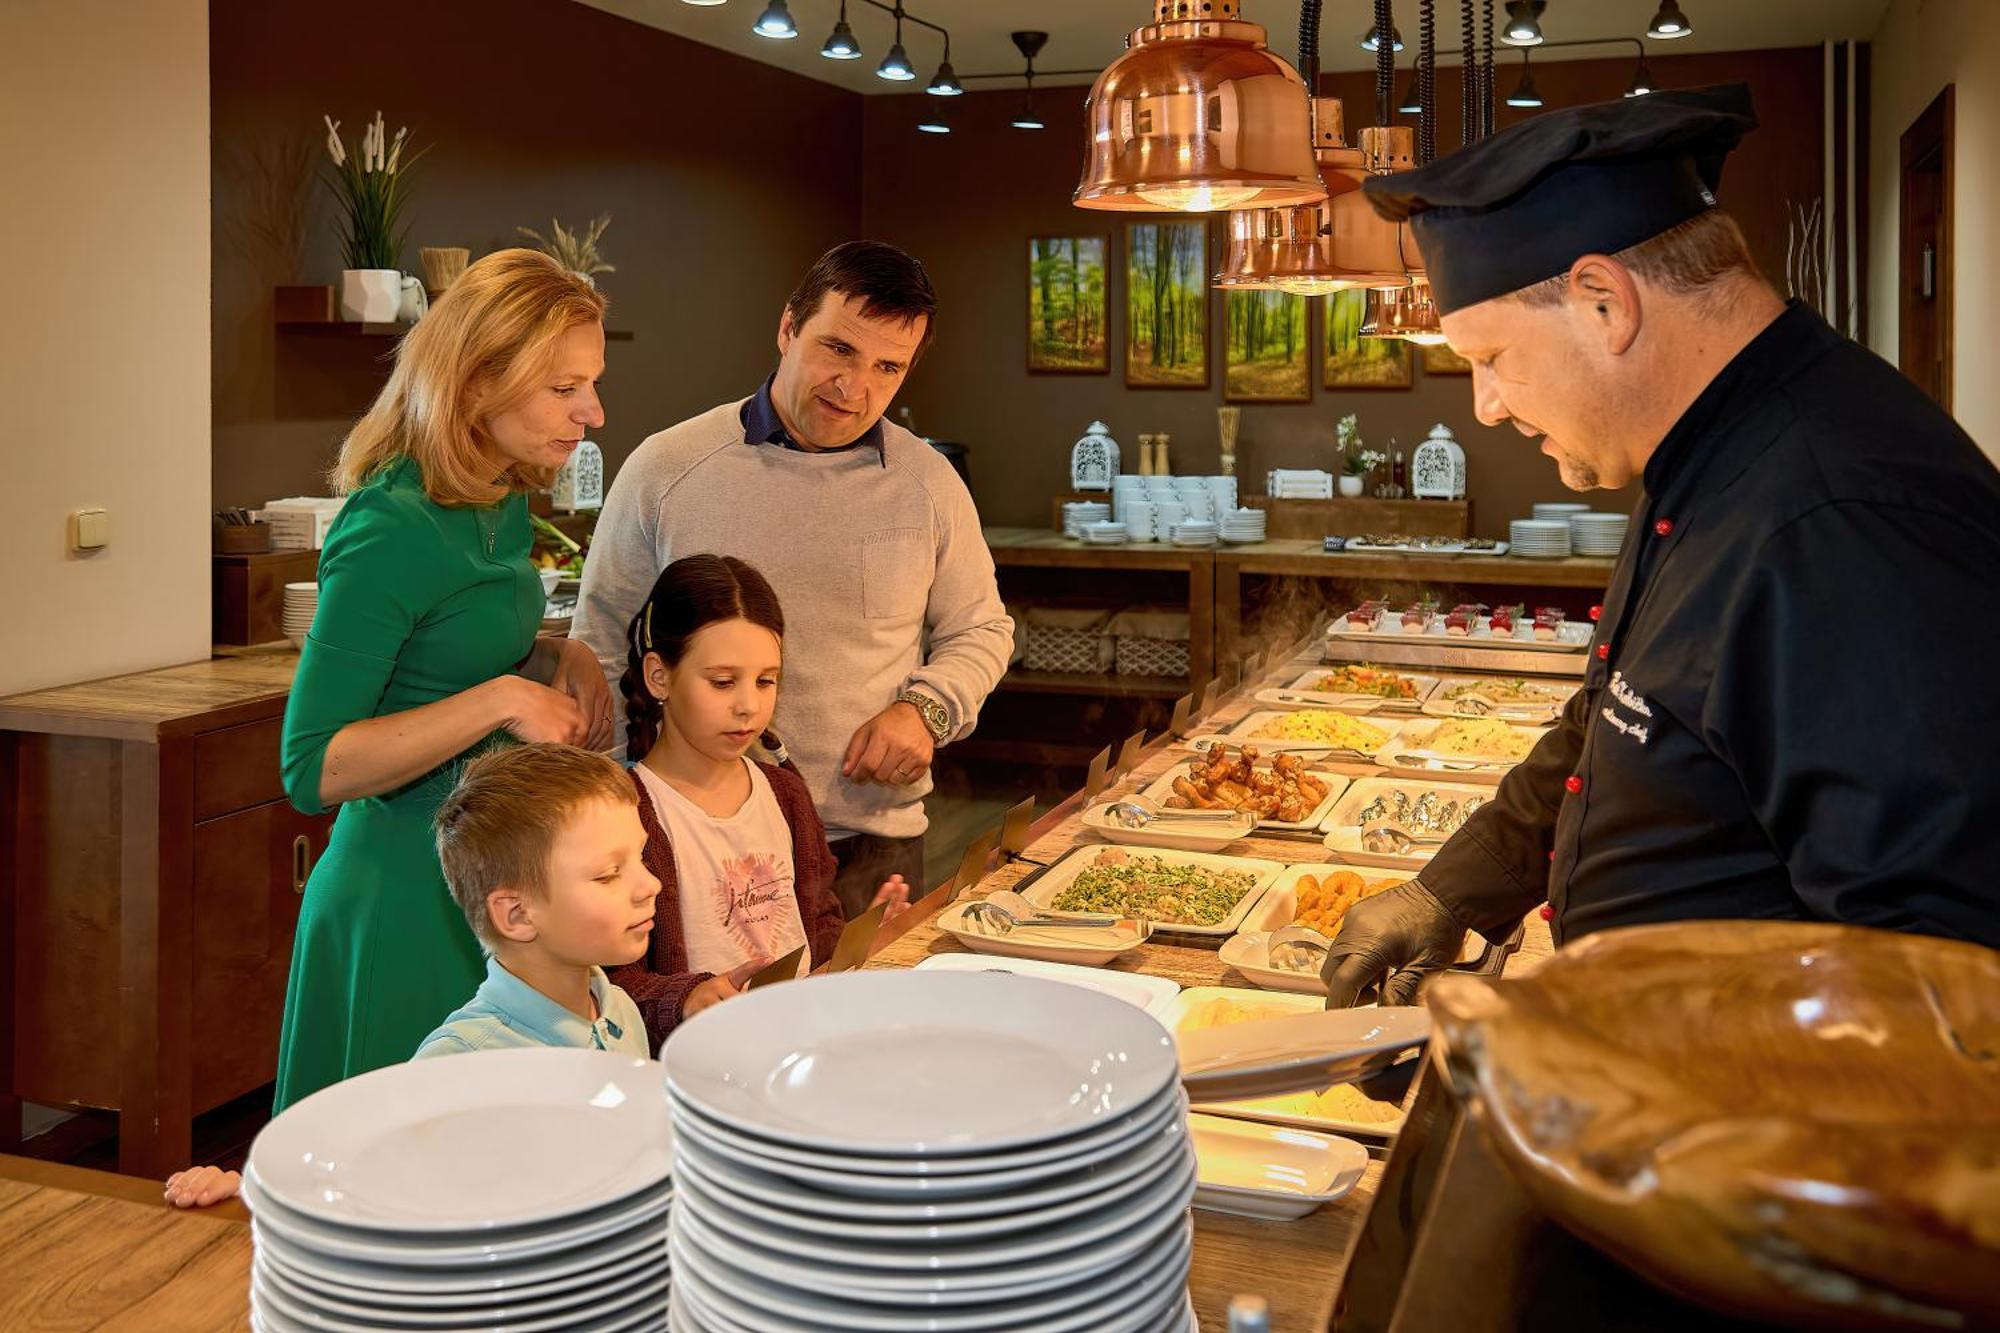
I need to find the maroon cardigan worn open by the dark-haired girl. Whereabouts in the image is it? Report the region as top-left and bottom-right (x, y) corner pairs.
(610, 765), (846, 1053)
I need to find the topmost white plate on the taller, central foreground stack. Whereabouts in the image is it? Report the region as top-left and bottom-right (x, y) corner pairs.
(664, 971), (1178, 1157)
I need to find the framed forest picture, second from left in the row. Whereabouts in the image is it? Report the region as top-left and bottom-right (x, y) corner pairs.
(1124, 222), (1208, 388)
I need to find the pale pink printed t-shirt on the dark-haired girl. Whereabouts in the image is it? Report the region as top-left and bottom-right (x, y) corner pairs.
(638, 759), (812, 975)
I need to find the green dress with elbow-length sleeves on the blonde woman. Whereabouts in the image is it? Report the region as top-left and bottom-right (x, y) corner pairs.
(276, 458), (544, 1111)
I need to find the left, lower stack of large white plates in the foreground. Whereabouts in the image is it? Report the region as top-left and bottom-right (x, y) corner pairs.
(244, 1048), (672, 1333)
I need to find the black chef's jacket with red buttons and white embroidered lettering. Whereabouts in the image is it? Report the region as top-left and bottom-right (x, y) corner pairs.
(1422, 306), (2000, 945)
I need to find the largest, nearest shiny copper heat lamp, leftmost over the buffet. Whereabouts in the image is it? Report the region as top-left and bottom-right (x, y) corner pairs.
(1074, 0), (1326, 212)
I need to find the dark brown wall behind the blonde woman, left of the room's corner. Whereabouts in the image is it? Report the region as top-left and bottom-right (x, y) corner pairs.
(210, 0), (862, 504)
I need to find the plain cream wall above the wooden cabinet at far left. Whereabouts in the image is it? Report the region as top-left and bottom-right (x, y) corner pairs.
(0, 0), (210, 695)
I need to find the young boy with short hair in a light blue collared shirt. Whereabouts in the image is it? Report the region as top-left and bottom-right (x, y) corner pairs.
(166, 745), (660, 1207)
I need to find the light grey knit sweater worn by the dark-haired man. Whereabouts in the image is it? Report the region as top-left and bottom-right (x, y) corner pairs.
(570, 402), (1014, 837)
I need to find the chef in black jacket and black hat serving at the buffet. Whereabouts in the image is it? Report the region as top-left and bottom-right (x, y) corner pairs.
(1324, 86), (2000, 1007)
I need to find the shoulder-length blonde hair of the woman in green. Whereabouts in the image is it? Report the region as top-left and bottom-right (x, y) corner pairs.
(332, 250), (606, 504)
